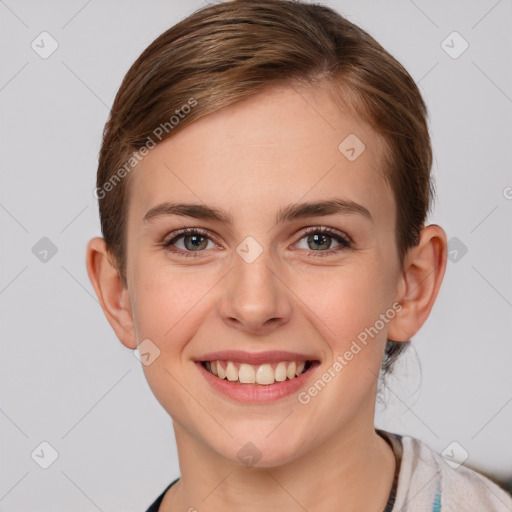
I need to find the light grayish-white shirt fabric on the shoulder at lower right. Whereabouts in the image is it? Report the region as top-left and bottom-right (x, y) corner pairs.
(393, 436), (512, 512)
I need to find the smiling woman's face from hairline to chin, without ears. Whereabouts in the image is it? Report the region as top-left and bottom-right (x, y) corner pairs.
(123, 83), (400, 466)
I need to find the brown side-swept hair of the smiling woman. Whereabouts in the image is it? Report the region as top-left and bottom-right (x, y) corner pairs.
(96, 0), (434, 374)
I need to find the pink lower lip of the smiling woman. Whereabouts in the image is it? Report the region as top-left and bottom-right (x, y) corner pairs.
(196, 362), (318, 403)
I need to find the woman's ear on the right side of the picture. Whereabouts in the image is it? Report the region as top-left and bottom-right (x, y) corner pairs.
(387, 224), (447, 341)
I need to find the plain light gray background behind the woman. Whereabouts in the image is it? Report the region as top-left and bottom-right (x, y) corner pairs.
(0, 0), (512, 512)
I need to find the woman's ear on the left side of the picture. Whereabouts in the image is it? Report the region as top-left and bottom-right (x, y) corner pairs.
(86, 237), (137, 349)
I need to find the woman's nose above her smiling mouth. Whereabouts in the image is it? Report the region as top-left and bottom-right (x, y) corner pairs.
(218, 250), (292, 336)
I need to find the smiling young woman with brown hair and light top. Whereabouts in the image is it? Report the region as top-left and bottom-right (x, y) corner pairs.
(87, 0), (512, 512)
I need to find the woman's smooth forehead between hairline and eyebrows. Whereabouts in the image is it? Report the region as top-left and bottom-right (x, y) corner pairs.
(130, 83), (393, 226)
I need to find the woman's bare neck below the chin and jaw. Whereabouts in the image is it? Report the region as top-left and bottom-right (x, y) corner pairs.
(160, 418), (395, 512)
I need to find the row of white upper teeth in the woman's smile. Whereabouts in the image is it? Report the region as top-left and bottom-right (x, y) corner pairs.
(205, 361), (312, 385)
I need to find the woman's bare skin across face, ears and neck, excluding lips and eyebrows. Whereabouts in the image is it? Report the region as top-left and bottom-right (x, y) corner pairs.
(87, 87), (446, 512)
